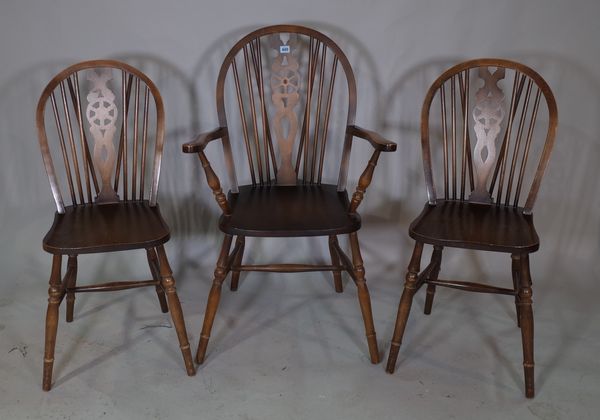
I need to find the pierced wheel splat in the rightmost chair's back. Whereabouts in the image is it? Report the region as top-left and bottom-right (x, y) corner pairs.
(469, 67), (505, 203)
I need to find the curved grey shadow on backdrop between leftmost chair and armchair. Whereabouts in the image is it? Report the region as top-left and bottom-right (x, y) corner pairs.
(109, 53), (219, 285)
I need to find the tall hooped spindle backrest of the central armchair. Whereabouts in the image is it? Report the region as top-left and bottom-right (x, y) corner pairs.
(217, 25), (356, 192)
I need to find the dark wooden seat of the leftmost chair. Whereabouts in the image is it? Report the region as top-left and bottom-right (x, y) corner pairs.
(43, 200), (170, 255)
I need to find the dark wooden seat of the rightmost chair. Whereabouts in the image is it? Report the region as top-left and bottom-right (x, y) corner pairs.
(408, 200), (540, 253)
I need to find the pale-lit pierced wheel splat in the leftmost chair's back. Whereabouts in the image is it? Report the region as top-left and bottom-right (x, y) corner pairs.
(86, 68), (119, 202)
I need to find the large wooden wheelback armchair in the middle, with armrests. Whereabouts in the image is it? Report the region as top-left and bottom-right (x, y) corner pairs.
(183, 25), (396, 363)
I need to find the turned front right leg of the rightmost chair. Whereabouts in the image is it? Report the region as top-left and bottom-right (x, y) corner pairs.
(519, 254), (535, 398)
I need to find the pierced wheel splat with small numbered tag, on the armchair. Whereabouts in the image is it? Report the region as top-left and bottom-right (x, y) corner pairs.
(271, 34), (300, 185)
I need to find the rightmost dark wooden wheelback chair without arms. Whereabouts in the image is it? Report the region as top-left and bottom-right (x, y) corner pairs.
(387, 59), (557, 398)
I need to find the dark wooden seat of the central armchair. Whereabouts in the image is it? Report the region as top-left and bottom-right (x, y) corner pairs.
(219, 184), (360, 237)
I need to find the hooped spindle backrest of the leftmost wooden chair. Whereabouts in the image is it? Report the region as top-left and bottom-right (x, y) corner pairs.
(36, 60), (164, 213)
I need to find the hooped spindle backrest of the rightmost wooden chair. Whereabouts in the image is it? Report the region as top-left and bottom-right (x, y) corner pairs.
(421, 59), (557, 213)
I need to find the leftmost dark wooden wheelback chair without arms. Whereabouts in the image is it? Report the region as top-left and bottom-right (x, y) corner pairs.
(36, 60), (195, 391)
